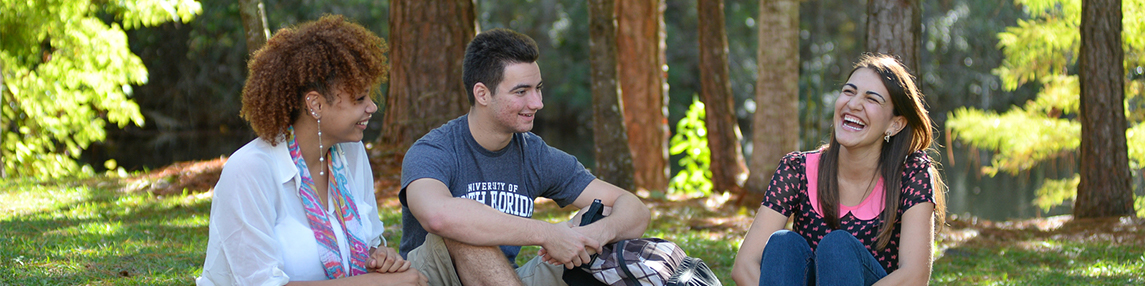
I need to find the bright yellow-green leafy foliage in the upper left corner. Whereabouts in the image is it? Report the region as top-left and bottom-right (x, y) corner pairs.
(0, 0), (200, 178)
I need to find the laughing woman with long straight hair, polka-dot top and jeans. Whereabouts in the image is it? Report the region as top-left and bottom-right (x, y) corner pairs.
(732, 54), (946, 285)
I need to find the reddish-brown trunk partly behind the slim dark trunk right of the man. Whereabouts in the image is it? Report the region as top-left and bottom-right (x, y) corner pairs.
(616, 0), (669, 191)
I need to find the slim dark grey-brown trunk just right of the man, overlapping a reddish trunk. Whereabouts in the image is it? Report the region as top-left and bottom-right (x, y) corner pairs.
(589, 0), (633, 191)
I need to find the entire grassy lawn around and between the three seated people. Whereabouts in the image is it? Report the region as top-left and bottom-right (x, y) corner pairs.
(0, 170), (1145, 285)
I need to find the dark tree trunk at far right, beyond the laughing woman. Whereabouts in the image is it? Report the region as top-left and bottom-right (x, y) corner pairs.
(1073, 0), (1135, 219)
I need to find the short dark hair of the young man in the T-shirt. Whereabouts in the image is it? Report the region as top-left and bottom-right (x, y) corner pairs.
(461, 29), (540, 105)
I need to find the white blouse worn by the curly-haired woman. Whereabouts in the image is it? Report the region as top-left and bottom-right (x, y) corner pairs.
(196, 138), (385, 285)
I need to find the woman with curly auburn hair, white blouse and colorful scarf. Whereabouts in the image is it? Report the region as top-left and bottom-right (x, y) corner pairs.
(196, 16), (426, 285)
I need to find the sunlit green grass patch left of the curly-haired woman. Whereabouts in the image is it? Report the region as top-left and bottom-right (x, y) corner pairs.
(0, 181), (211, 285)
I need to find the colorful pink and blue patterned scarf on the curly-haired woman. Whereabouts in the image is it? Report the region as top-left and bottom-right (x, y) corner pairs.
(286, 126), (370, 279)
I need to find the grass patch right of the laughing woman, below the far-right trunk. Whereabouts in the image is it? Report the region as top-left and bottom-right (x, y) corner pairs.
(931, 216), (1145, 285)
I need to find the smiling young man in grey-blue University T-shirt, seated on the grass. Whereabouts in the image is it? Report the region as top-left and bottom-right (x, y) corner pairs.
(398, 29), (650, 285)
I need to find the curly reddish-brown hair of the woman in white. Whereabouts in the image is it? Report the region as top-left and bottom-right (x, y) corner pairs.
(239, 15), (389, 145)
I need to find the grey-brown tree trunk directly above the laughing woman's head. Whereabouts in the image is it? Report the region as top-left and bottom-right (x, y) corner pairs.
(867, 0), (923, 74)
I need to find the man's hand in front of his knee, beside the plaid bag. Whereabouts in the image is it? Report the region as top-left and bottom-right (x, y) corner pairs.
(540, 222), (600, 269)
